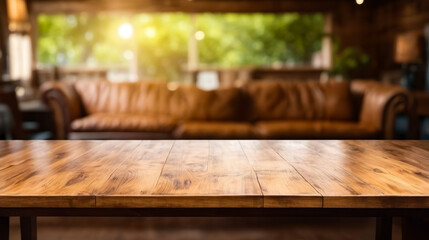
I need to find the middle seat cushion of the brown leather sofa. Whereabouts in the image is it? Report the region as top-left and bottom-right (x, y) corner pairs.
(174, 122), (255, 139)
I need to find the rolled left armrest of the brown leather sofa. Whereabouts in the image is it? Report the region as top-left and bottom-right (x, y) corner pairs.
(40, 82), (83, 139)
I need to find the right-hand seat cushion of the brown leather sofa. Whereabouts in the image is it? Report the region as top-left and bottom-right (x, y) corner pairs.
(255, 121), (378, 139)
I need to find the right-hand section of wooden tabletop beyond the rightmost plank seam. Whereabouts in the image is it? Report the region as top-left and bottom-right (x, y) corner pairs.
(271, 141), (429, 208)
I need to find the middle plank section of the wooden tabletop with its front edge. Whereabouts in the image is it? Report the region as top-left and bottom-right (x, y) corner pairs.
(152, 140), (263, 208)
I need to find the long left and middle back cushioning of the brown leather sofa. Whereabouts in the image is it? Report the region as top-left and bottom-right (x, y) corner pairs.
(75, 81), (240, 121)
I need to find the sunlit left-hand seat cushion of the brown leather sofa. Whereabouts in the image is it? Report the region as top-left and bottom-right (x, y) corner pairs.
(71, 113), (177, 132)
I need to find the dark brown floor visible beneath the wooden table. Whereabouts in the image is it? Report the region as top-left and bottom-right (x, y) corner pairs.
(7, 217), (401, 240)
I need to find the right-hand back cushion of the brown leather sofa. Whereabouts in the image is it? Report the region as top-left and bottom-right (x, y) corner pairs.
(244, 80), (356, 121)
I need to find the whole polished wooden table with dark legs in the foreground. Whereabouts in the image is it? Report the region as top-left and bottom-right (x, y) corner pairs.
(0, 140), (429, 239)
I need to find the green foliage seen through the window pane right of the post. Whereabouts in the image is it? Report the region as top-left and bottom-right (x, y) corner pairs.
(197, 13), (323, 67)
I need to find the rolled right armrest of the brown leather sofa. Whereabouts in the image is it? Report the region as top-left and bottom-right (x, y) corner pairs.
(351, 80), (410, 139)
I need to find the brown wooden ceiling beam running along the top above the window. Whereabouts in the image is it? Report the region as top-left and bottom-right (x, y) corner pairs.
(31, 0), (359, 13)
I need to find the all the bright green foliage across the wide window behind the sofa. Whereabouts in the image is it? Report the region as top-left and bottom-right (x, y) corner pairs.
(37, 13), (323, 80)
